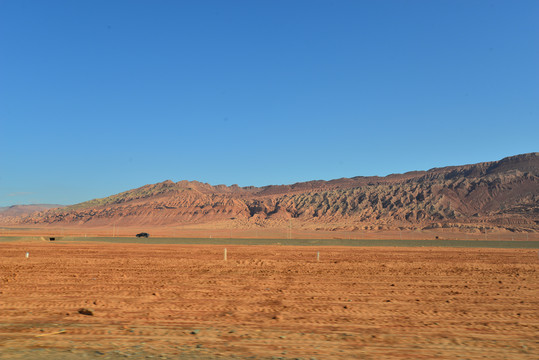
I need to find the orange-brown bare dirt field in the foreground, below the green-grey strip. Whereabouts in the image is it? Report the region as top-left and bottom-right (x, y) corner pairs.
(0, 242), (539, 359)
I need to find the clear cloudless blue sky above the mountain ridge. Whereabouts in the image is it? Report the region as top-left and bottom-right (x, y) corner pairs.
(0, 0), (539, 206)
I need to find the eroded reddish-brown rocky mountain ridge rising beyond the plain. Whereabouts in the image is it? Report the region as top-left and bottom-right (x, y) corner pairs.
(8, 153), (539, 231)
